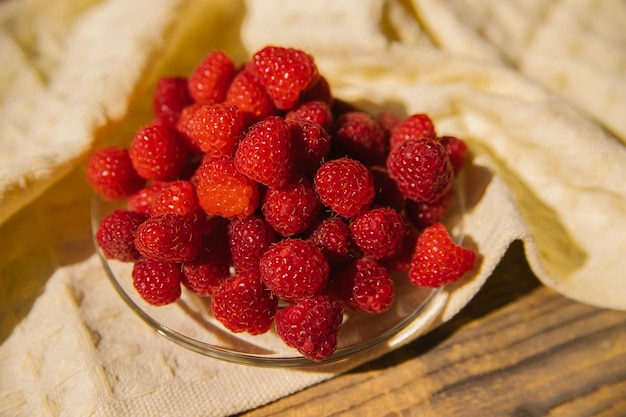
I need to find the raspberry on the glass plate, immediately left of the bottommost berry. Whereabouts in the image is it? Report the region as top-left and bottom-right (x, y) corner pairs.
(211, 269), (278, 335)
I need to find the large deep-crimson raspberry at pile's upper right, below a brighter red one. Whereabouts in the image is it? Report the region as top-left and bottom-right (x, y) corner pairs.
(387, 138), (454, 202)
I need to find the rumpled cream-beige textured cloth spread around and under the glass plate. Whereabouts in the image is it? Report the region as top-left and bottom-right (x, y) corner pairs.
(0, 0), (626, 416)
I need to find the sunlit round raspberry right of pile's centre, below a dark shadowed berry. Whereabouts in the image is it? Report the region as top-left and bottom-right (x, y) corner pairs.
(313, 158), (375, 218)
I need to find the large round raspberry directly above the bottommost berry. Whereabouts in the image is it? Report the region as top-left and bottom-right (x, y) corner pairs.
(259, 239), (329, 302)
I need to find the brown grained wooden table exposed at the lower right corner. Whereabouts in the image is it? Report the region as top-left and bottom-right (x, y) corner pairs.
(243, 243), (626, 417)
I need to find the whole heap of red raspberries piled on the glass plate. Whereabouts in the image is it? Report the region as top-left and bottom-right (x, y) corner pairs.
(87, 46), (476, 362)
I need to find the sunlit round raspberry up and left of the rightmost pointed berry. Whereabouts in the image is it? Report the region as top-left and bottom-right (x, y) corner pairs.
(350, 207), (404, 259)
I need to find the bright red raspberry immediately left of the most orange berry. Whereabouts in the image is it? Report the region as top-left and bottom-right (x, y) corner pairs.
(150, 180), (200, 216)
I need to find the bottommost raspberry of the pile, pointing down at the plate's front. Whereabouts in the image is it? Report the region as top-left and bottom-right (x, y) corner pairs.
(275, 295), (343, 362)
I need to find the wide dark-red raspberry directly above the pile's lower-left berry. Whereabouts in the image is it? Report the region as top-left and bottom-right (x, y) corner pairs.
(135, 213), (202, 263)
